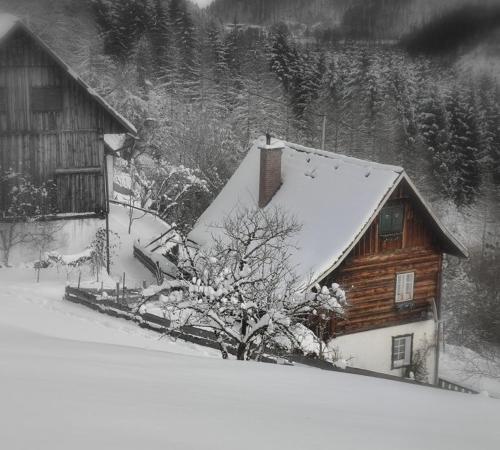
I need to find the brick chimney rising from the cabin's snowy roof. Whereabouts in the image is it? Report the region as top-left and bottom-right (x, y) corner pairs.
(259, 134), (285, 208)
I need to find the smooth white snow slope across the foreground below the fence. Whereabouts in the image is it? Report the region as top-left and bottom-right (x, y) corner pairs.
(0, 269), (500, 450)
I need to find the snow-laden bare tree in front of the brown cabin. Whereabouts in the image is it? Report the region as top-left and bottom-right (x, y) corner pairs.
(152, 209), (345, 360)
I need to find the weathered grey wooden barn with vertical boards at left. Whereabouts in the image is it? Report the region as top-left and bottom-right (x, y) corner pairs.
(0, 14), (136, 216)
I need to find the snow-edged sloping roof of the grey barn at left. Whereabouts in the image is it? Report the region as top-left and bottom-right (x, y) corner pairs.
(0, 13), (137, 134)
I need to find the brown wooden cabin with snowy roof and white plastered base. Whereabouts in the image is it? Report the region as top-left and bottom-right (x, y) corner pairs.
(189, 138), (467, 381)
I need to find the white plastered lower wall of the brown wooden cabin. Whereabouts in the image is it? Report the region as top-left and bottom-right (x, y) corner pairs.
(329, 320), (435, 383)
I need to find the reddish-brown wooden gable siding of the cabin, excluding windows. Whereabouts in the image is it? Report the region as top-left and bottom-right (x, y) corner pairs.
(324, 184), (442, 335)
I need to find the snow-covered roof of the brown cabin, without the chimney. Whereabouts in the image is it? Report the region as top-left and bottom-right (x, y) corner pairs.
(189, 138), (467, 282)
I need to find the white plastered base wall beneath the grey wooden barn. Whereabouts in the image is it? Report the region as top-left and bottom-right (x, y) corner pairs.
(0, 218), (105, 265)
